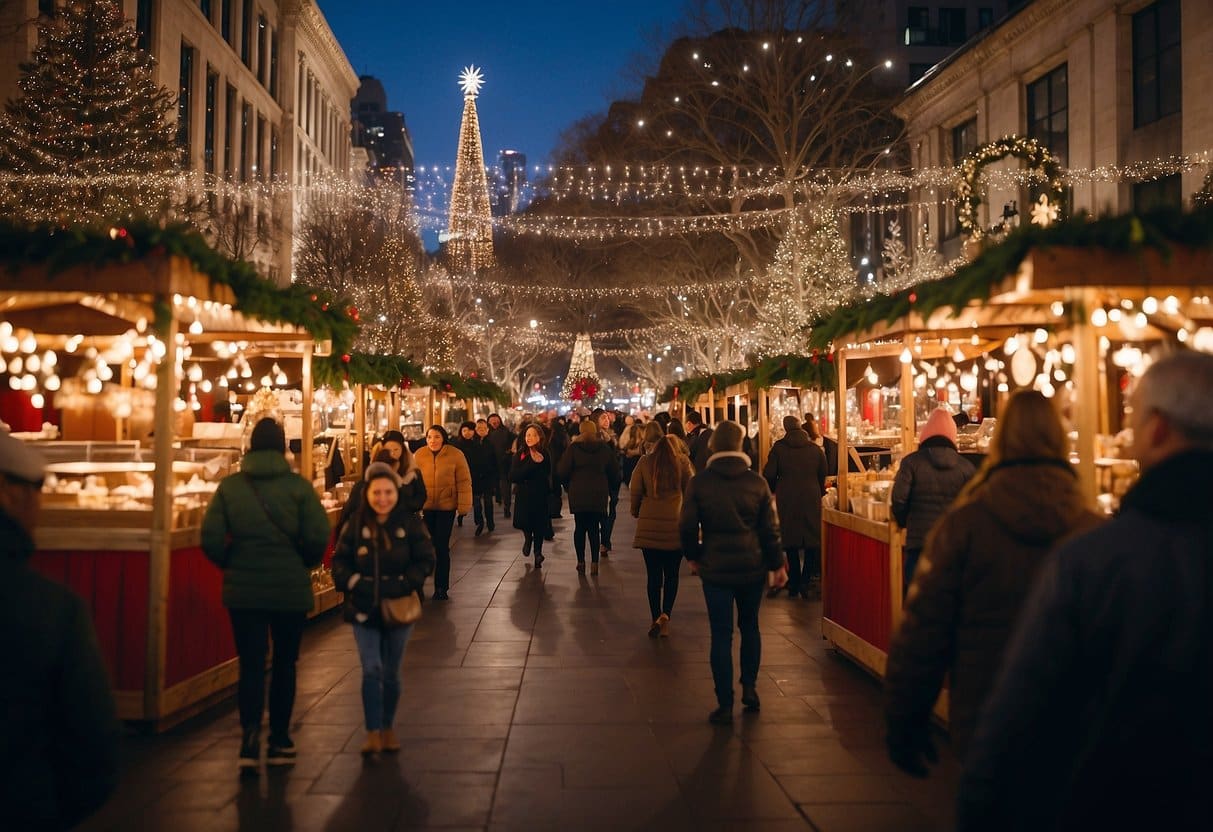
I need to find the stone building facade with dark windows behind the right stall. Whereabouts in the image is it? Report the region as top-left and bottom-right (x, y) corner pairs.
(896, 0), (1213, 255)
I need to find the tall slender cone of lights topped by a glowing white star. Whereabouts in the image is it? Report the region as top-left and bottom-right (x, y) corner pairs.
(446, 67), (492, 274)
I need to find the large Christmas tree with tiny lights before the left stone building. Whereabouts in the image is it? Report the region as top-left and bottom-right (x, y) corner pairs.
(0, 0), (180, 221)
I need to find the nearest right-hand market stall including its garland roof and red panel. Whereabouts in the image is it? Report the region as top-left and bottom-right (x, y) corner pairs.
(814, 208), (1213, 674)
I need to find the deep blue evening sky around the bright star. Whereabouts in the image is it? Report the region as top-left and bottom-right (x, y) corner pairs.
(319, 0), (684, 166)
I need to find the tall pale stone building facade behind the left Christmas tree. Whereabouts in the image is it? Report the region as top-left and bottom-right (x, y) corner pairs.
(0, 0), (358, 283)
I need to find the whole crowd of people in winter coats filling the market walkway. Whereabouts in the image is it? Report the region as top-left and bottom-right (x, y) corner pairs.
(0, 353), (1213, 831)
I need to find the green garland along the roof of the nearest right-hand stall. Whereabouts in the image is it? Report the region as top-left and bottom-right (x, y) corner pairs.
(809, 207), (1213, 348)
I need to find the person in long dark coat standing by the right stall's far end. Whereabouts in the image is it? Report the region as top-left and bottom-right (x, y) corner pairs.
(762, 416), (826, 598)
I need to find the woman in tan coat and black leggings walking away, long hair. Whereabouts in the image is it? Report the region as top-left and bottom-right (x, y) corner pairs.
(628, 436), (695, 638)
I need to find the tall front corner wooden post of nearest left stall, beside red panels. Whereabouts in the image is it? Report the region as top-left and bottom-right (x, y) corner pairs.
(143, 312), (181, 720)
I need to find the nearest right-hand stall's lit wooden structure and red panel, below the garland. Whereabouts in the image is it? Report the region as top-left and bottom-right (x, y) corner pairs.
(822, 240), (1213, 676)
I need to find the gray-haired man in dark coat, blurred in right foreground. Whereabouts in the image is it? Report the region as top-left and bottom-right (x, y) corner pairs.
(957, 352), (1213, 832)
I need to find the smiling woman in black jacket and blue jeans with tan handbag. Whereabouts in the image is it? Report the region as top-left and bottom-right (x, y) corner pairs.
(332, 462), (434, 754)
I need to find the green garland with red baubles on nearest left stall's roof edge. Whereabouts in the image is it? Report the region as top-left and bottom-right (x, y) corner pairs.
(0, 220), (358, 354)
